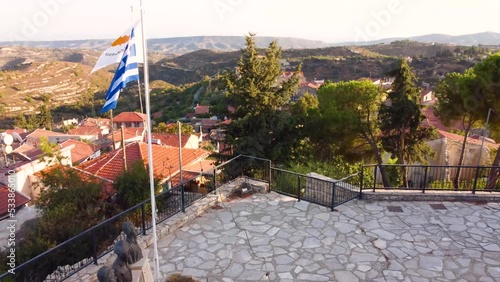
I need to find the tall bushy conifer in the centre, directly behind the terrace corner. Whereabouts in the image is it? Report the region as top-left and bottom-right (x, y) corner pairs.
(222, 34), (300, 162)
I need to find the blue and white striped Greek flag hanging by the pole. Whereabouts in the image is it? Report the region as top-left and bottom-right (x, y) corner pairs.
(101, 28), (139, 114)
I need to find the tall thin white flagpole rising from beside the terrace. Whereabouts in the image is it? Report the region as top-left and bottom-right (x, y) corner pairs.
(140, 0), (160, 281)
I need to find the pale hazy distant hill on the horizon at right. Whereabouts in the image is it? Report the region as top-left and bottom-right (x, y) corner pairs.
(331, 32), (500, 46)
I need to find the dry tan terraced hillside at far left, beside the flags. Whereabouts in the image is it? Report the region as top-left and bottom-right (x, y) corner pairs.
(0, 61), (112, 120)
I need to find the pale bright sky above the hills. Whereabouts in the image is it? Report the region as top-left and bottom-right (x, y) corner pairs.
(0, 0), (500, 43)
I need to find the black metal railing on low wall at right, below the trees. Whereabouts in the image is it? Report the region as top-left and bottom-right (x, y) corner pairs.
(361, 165), (500, 193)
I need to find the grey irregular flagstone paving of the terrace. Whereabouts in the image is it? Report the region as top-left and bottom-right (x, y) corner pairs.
(150, 193), (500, 282)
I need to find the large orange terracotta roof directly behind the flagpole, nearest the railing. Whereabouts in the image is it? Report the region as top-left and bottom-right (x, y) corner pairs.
(78, 142), (209, 181)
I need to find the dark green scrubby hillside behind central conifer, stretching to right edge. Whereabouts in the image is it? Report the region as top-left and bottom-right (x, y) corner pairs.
(150, 40), (496, 85)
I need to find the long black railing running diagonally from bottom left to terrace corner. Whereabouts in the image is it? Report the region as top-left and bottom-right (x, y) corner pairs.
(0, 156), (271, 282)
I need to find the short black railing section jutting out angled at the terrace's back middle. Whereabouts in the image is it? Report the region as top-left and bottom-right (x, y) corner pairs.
(271, 167), (361, 210)
